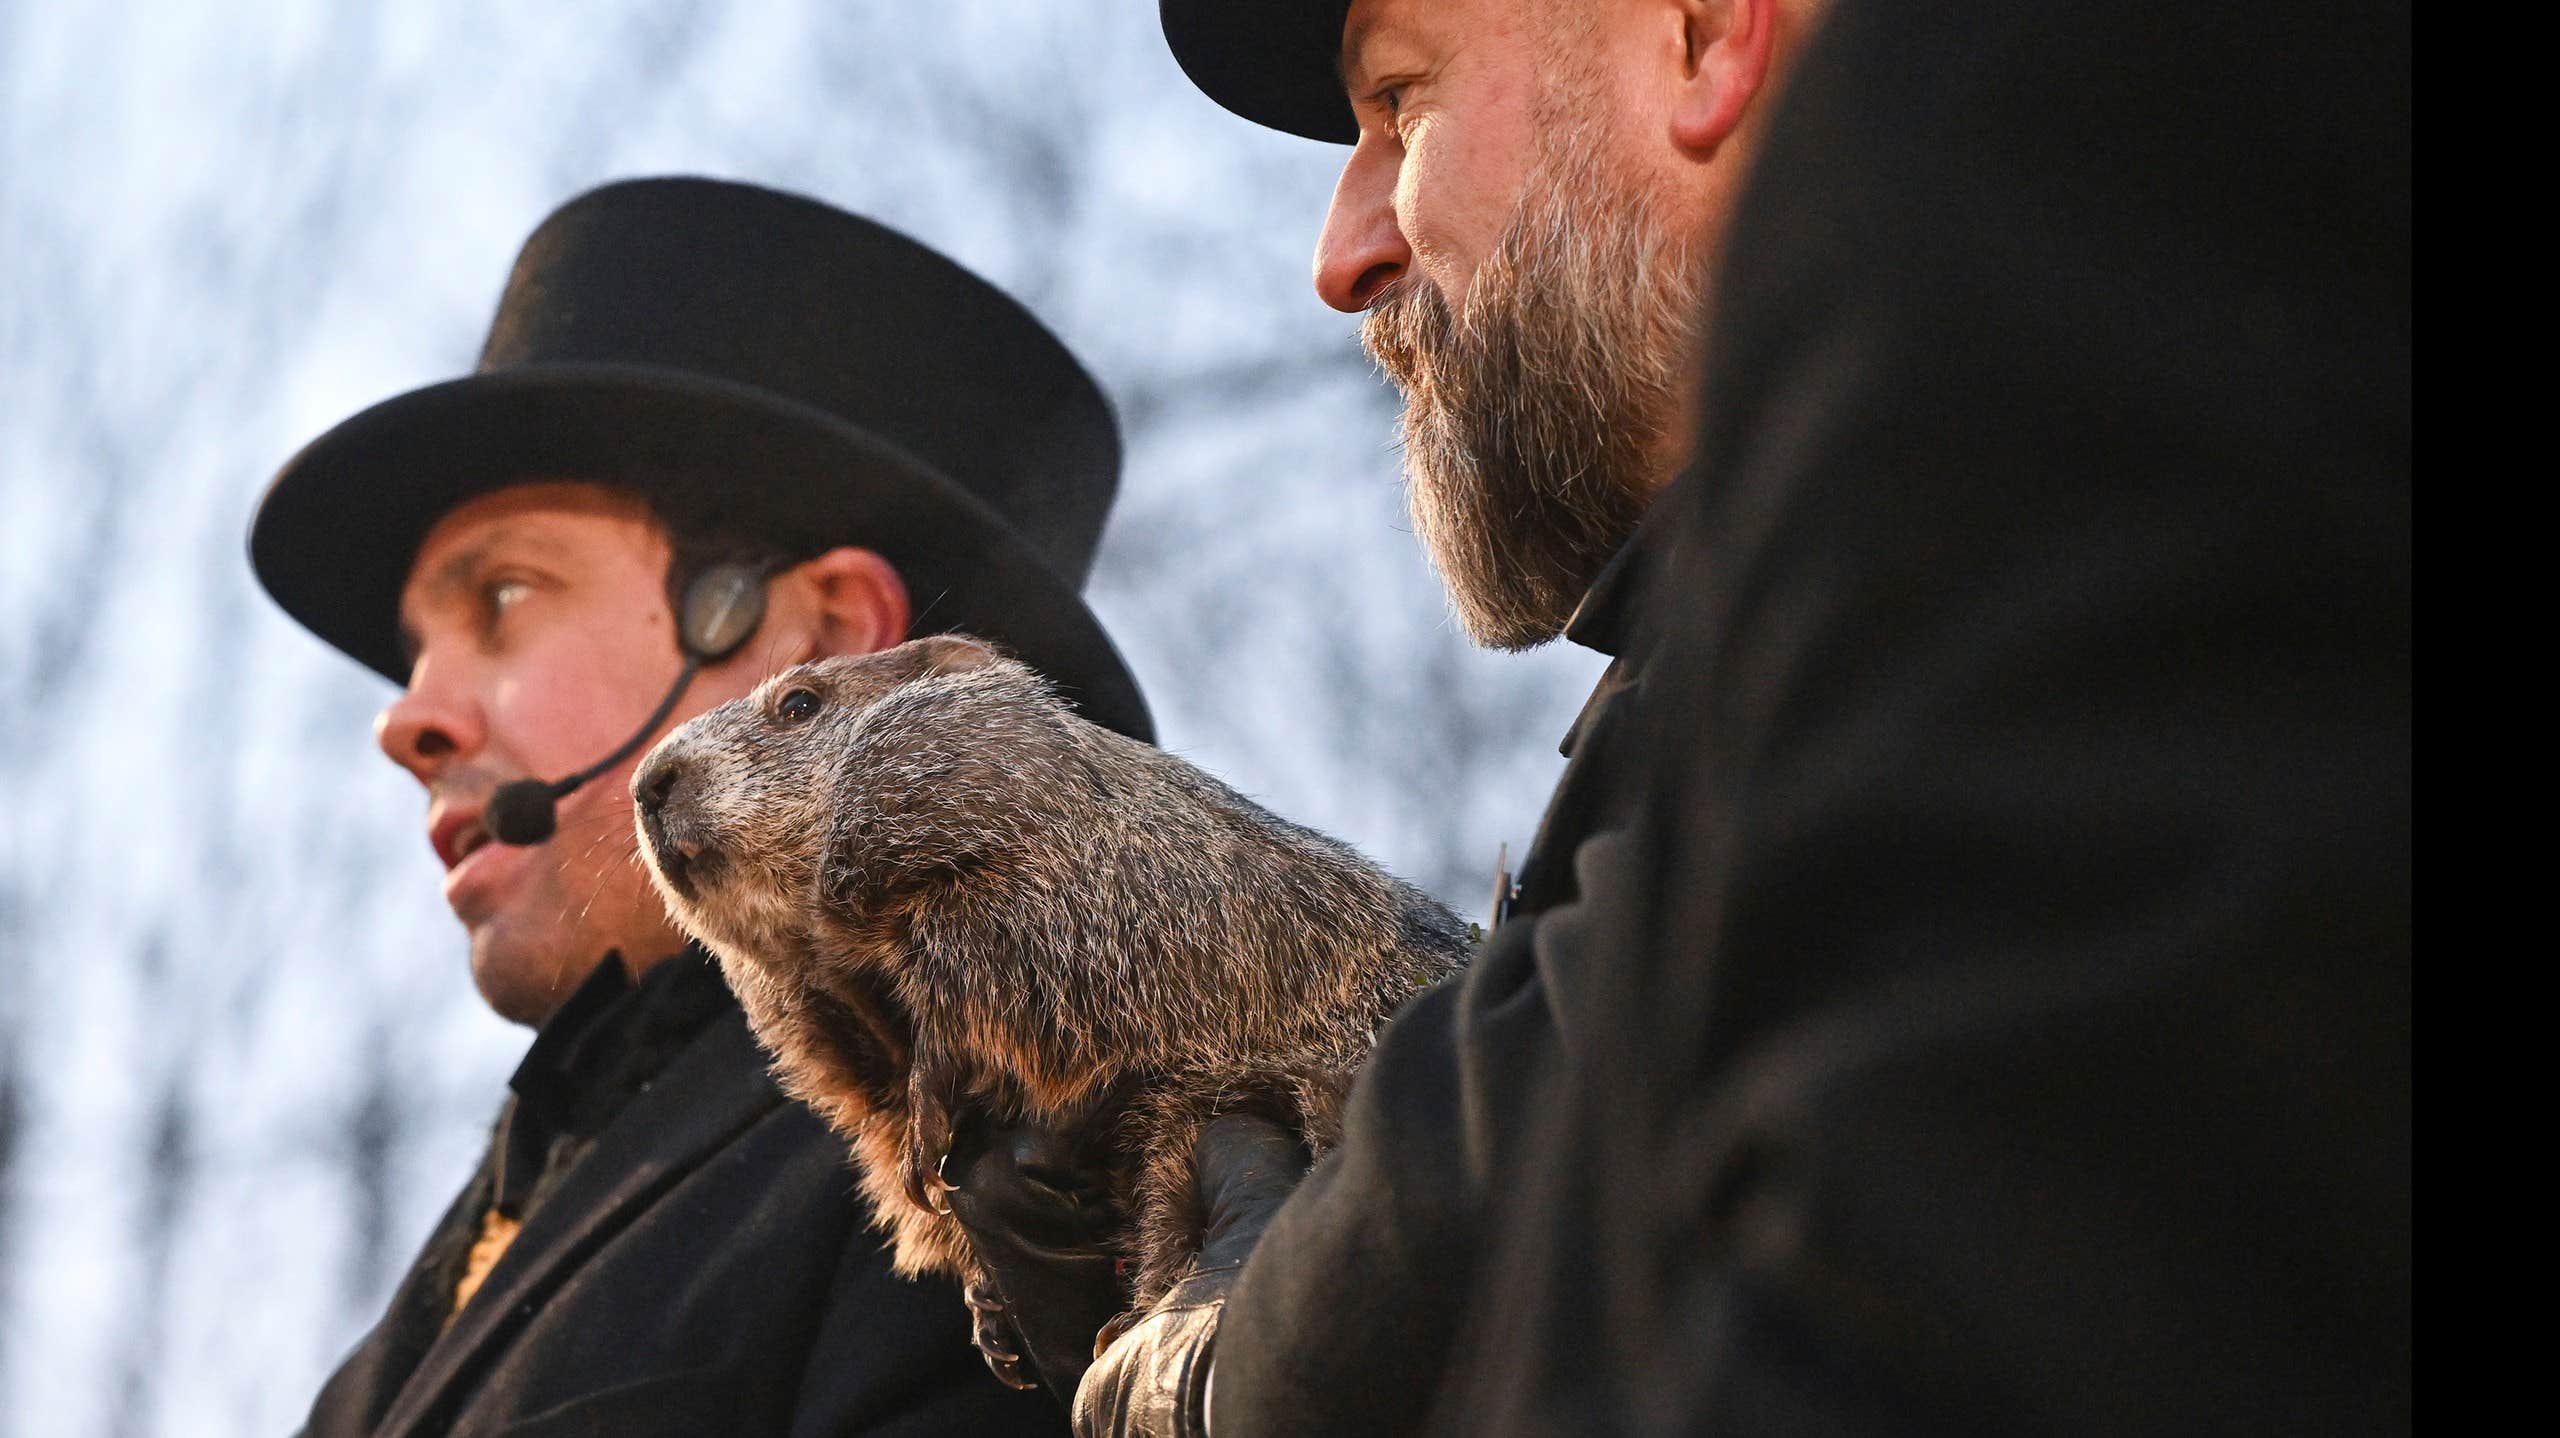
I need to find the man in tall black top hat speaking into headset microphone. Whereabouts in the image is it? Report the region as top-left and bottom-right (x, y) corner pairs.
(248, 179), (1149, 1438)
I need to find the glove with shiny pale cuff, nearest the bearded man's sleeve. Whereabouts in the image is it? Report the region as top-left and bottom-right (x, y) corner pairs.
(1075, 1116), (1308, 1438)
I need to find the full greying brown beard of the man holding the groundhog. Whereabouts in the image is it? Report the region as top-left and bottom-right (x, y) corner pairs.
(1359, 128), (1705, 650)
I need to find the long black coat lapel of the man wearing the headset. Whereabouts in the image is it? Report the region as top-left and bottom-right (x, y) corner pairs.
(379, 1008), (783, 1438)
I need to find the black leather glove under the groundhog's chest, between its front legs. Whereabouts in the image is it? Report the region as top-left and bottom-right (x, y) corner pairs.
(942, 1116), (1129, 1405)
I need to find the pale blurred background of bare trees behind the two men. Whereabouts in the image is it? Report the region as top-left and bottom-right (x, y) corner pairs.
(0, 0), (1597, 1438)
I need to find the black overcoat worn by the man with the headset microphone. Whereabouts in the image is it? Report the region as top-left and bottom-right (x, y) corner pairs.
(307, 1006), (1065, 1438)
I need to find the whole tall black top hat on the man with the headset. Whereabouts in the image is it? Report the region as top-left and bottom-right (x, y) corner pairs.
(248, 179), (1152, 739)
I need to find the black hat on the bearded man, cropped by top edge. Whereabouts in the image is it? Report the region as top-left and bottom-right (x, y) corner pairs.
(1157, 0), (1359, 146)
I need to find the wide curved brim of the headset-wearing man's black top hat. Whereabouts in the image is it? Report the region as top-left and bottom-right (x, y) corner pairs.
(248, 363), (1155, 742)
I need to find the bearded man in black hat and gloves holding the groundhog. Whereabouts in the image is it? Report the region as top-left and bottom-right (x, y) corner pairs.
(945, 0), (1818, 1433)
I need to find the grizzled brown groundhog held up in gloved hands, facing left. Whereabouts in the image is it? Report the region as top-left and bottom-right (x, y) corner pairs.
(632, 635), (1467, 1308)
